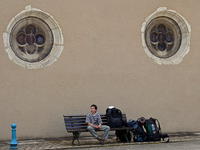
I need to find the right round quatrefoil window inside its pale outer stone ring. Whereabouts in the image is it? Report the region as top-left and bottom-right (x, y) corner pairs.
(145, 16), (181, 58)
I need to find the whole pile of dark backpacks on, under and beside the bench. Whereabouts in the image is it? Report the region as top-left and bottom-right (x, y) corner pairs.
(106, 106), (169, 142)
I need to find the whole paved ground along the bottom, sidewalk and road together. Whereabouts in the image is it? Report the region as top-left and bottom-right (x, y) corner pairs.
(0, 133), (200, 150)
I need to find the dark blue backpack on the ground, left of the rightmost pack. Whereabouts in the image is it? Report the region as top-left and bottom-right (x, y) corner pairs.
(127, 120), (147, 142)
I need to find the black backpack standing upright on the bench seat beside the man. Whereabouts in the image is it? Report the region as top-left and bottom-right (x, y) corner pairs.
(106, 108), (124, 128)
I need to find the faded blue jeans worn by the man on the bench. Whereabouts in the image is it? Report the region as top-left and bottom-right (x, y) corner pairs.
(87, 125), (110, 140)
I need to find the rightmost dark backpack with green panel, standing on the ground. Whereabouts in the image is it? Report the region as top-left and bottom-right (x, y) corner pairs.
(144, 118), (169, 142)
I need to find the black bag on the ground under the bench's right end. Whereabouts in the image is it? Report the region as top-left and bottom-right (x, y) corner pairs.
(115, 129), (132, 143)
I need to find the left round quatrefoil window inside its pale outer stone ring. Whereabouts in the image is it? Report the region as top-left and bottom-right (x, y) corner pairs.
(10, 17), (53, 62)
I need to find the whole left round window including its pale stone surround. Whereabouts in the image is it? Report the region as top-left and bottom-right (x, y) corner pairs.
(3, 5), (64, 69)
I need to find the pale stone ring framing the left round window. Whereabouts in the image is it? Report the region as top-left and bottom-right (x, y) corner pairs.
(3, 5), (64, 69)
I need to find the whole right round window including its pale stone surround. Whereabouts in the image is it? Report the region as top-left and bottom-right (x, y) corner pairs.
(141, 7), (191, 64)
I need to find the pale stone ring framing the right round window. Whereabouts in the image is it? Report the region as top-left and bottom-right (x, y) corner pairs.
(141, 7), (191, 64)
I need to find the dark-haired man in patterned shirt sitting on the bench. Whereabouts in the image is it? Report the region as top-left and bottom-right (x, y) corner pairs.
(86, 104), (110, 144)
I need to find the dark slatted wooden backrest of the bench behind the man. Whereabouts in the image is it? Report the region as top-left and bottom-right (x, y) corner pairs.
(63, 114), (127, 132)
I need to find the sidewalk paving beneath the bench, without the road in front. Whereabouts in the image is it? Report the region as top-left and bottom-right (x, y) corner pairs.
(0, 132), (200, 150)
